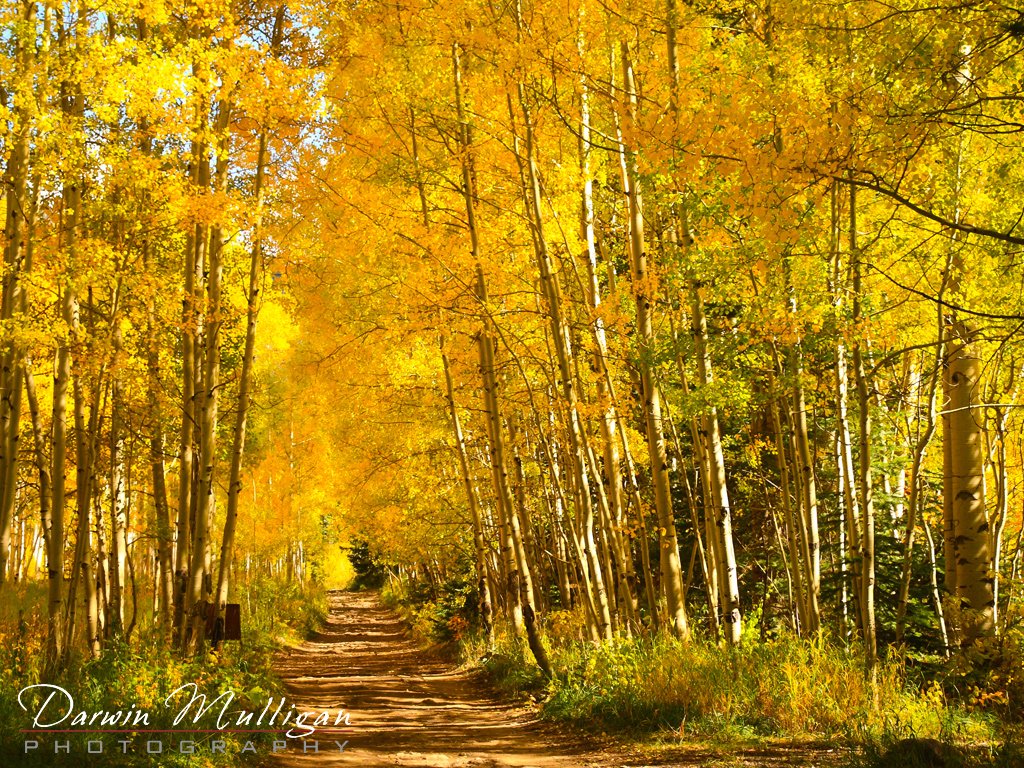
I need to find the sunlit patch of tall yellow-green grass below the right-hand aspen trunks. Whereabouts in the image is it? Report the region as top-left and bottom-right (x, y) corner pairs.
(544, 635), (1007, 743)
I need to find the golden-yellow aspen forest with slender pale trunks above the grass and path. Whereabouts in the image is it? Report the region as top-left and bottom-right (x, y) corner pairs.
(0, 0), (1024, 708)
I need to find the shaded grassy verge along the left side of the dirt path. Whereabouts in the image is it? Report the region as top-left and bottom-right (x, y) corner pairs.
(0, 581), (326, 768)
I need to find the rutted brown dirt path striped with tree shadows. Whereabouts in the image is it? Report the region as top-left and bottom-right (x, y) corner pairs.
(269, 592), (841, 768)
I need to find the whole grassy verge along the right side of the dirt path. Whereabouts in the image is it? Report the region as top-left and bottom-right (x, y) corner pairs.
(384, 585), (1024, 768)
